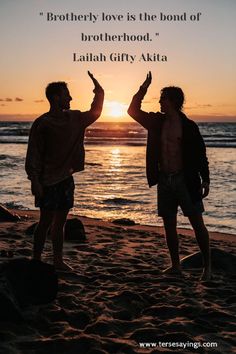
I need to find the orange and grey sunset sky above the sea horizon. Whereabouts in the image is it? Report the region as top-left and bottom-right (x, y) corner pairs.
(0, 0), (236, 121)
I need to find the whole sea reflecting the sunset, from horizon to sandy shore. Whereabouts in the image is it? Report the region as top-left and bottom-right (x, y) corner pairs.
(0, 122), (236, 234)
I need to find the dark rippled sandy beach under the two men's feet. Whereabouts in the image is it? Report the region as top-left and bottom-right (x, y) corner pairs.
(0, 210), (236, 354)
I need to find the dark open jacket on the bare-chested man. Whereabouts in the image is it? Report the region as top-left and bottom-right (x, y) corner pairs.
(128, 87), (210, 201)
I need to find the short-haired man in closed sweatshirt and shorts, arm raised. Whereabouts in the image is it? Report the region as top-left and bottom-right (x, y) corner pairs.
(25, 72), (104, 270)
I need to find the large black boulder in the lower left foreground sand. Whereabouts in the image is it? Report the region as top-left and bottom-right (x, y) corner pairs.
(0, 258), (58, 323)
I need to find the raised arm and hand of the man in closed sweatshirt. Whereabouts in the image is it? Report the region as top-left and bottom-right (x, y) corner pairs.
(82, 71), (104, 127)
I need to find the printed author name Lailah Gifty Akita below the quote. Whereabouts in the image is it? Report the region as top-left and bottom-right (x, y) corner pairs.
(72, 53), (168, 64)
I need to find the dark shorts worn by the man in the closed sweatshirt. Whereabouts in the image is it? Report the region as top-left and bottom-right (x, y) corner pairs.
(35, 176), (75, 211)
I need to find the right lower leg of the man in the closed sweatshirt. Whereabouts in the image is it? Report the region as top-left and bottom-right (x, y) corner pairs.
(51, 210), (72, 270)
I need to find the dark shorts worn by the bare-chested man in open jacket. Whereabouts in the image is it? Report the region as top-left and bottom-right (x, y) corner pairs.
(158, 172), (204, 217)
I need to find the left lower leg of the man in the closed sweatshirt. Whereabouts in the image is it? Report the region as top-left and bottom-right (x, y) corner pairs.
(33, 209), (53, 260)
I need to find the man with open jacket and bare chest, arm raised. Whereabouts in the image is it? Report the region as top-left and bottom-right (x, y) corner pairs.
(128, 72), (211, 280)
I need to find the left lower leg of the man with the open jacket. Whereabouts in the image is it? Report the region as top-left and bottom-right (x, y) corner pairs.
(163, 215), (181, 274)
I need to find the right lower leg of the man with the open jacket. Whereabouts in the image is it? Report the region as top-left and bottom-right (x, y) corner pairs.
(189, 214), (211, 280)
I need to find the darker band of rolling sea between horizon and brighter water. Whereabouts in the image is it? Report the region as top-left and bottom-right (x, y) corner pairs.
(0, 122), (236, 148)
